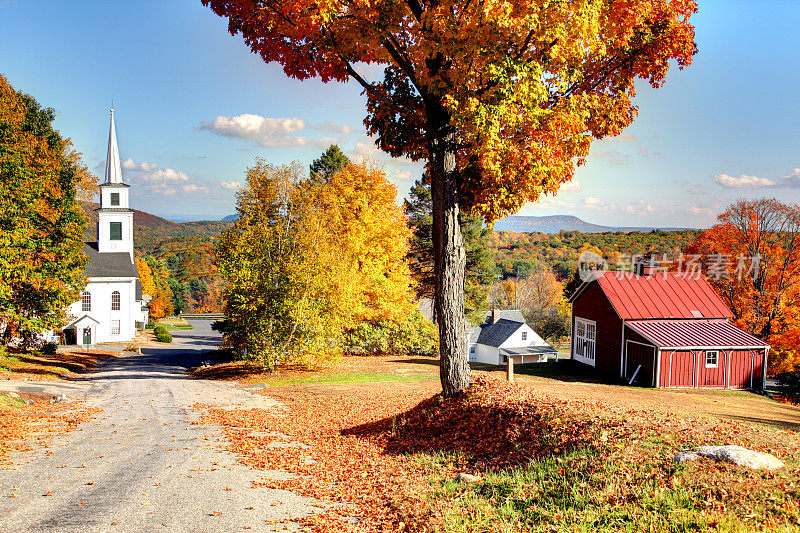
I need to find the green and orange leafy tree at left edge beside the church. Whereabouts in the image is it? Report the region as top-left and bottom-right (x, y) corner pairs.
(0, 76), (91, 345)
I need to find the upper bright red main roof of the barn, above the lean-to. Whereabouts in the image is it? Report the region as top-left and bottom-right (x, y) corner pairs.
(570, 271), (733, 320)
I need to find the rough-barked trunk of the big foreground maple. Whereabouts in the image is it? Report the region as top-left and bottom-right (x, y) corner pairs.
(428, 103), (472, 397)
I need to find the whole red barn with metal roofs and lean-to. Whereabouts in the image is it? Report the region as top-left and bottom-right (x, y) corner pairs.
(569, 271), (769, 389)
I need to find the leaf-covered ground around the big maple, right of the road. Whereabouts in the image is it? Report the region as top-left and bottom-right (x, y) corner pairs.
(198, 375), (800, 531)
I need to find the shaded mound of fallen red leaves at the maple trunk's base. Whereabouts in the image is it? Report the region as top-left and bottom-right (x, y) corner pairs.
(342, 376), (602, 471)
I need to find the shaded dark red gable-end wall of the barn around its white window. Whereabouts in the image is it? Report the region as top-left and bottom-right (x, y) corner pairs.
(572, 283), (622, 378)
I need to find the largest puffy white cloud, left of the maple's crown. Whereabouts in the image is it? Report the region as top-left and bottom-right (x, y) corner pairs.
(197, 113), (340, 148)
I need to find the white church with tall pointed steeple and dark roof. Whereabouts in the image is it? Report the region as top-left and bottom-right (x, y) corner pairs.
(64, 109), (149, 346)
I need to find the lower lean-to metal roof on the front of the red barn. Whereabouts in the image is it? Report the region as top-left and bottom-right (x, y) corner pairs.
(625, 320), (769, 350)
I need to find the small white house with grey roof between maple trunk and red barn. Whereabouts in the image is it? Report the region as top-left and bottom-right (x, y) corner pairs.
(467, 309), (557, 365)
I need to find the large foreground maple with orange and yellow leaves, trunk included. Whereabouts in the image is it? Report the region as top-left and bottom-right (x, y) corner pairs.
(203, 0), (697, 396)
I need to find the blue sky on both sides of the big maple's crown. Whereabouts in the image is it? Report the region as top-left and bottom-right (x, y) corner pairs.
(0, 0), (800, 227)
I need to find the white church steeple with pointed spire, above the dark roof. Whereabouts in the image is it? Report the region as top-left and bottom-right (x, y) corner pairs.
(97, 109), (133, 259)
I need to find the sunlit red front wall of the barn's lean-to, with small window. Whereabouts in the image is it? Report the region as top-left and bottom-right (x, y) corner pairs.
(660, 349), (764, 389)
